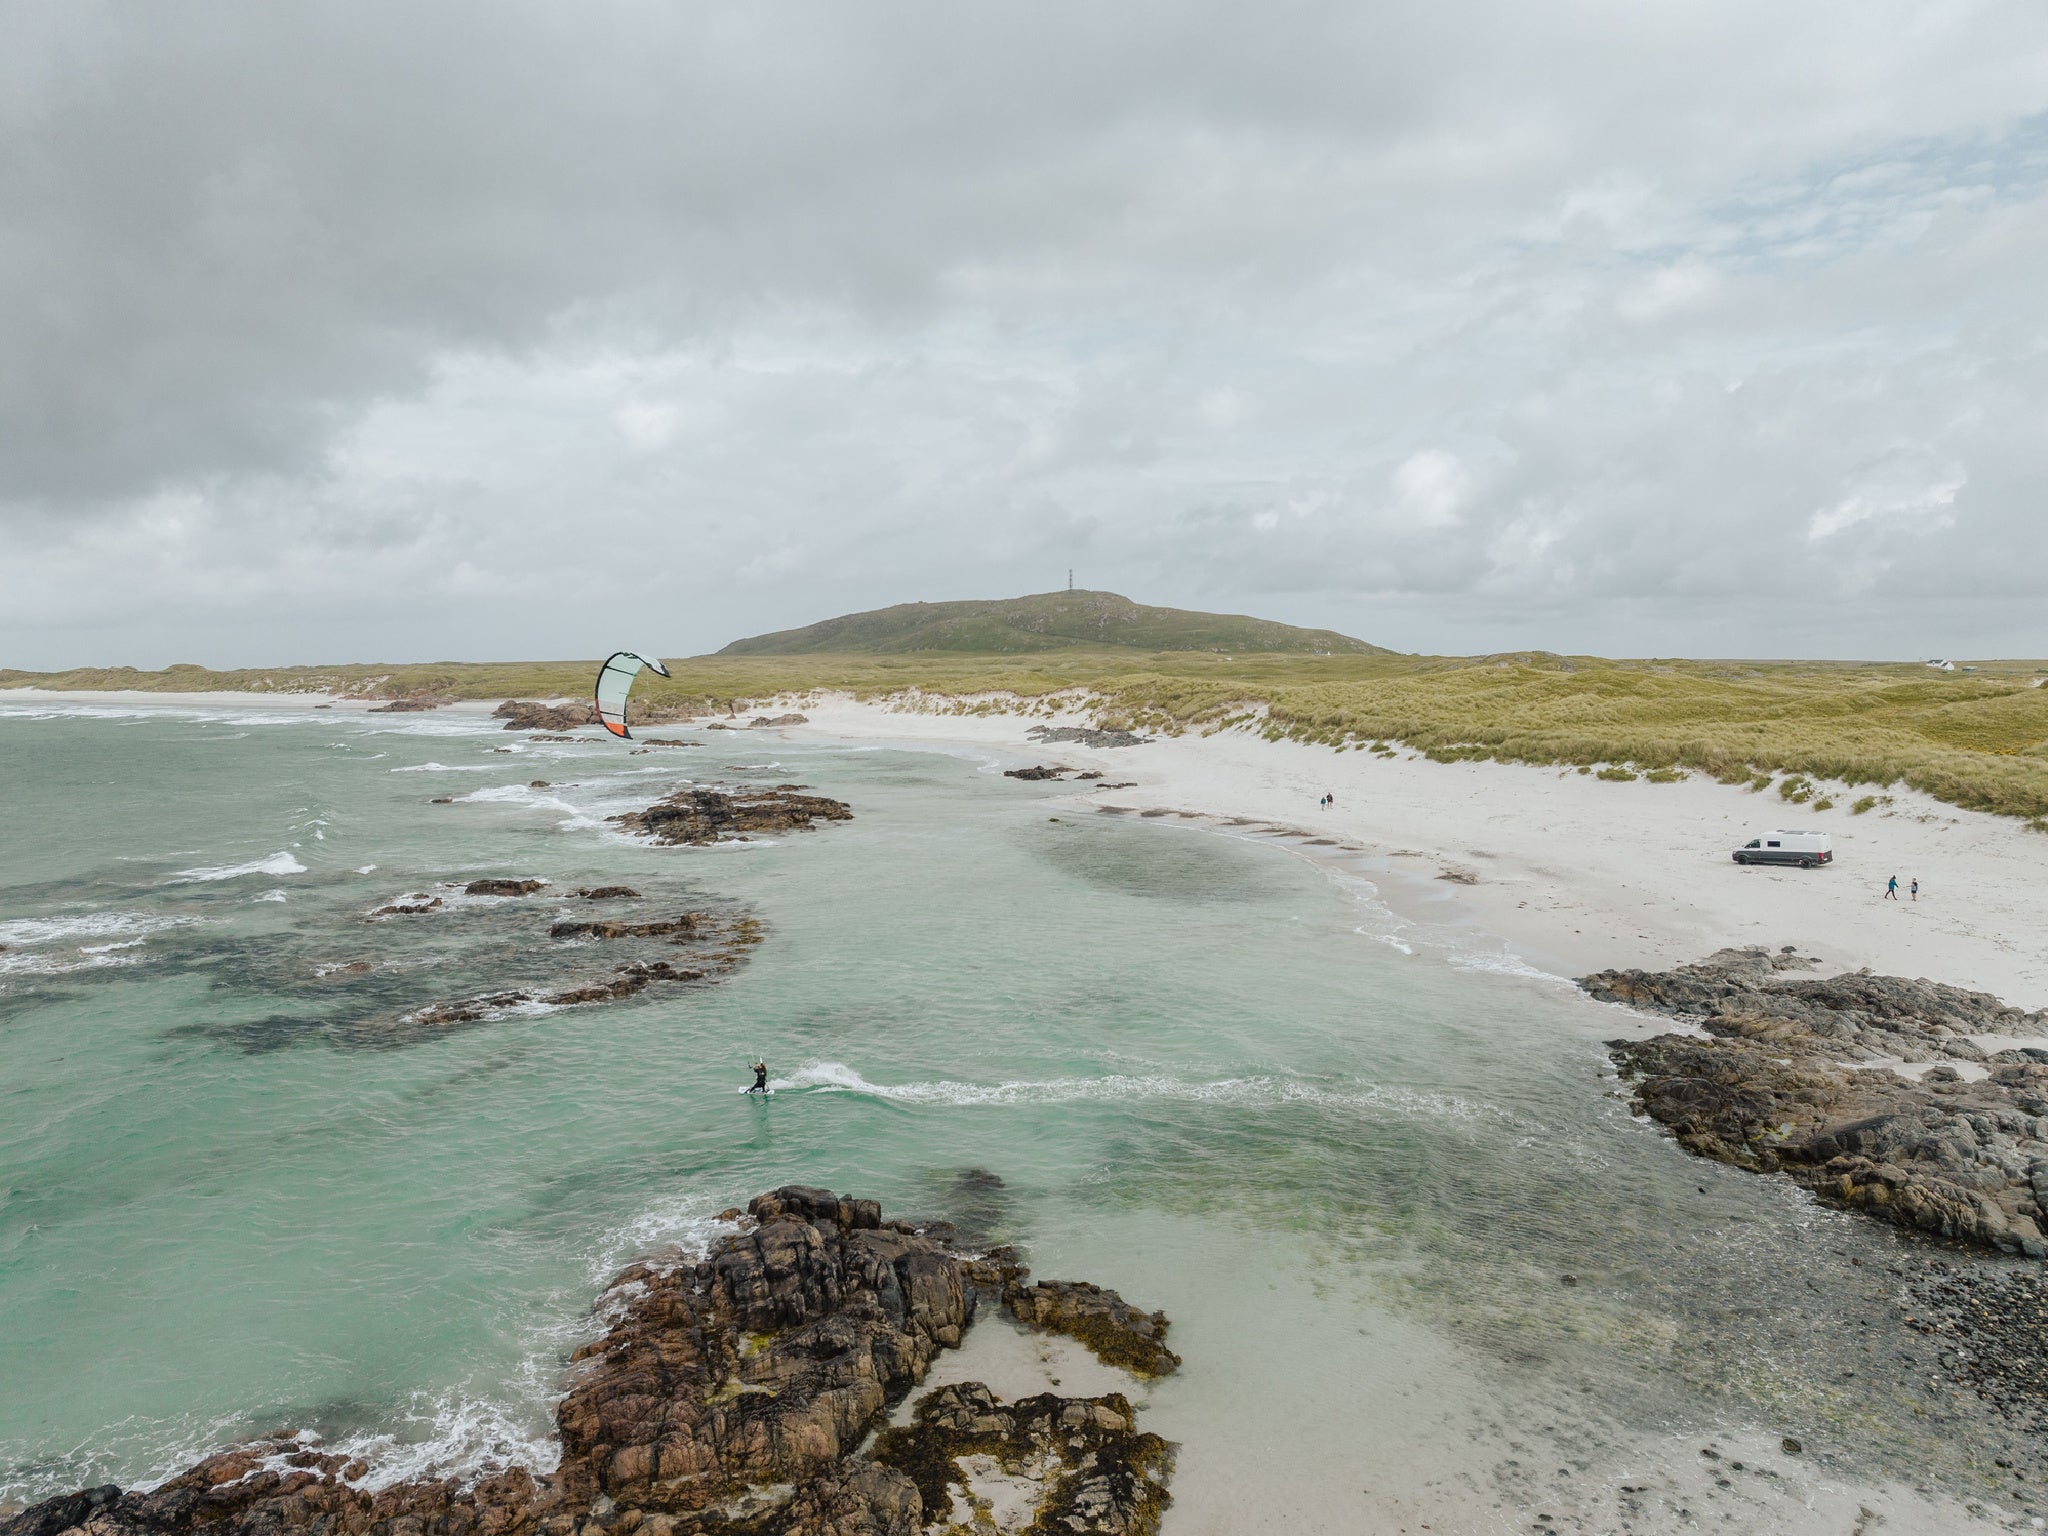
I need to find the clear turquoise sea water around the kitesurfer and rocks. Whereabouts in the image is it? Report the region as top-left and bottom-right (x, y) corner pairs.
(0, 705), (2003, 1532)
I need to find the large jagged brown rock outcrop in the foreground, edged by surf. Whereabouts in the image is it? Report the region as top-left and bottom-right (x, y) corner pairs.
(0, 1186), (1171, 1536)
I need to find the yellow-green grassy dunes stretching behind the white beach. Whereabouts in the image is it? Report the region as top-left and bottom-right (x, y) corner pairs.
(0, 647), (2048, 829)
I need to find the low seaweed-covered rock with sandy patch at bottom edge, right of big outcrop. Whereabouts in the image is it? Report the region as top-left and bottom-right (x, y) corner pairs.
(874, 1380), (1174, 1536)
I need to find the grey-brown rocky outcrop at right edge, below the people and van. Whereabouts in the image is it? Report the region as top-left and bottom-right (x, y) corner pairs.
(1579, 948), (2048, 1257)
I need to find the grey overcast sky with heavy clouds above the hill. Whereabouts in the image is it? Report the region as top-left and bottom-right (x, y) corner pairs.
(0, 0), (2048, 668)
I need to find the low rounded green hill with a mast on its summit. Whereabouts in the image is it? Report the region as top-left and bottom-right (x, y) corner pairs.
(719, 592), (1393, 655)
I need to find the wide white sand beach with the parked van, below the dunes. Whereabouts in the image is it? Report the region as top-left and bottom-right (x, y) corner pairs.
(793, 698), (2048, 1010)
